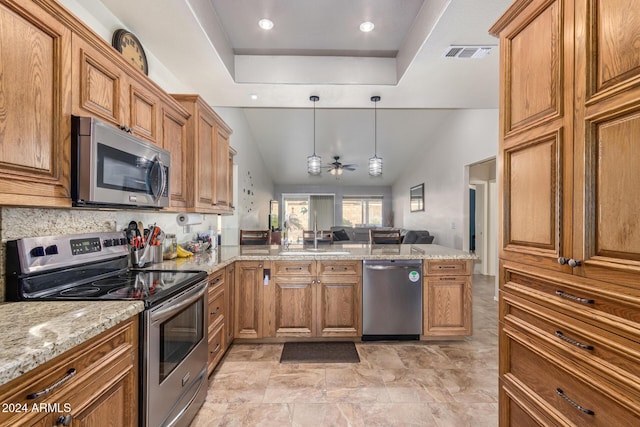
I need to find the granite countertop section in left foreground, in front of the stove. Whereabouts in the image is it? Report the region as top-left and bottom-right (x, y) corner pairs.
(0, 301), (144, 385)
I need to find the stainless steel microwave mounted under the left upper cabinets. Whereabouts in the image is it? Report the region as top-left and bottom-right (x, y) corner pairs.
(71, 116), (171, 209)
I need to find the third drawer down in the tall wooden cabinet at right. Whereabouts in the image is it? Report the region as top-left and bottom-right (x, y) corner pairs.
(500, 325), (640, 427)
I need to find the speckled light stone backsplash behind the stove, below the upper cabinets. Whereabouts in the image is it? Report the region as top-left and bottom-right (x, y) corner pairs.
(0, 207), (218, 301)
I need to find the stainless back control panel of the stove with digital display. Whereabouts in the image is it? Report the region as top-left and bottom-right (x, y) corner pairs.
(11, 232), (129, 274)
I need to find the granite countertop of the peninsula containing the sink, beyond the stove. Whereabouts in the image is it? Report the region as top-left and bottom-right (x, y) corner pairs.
(154, 243), (476, 273)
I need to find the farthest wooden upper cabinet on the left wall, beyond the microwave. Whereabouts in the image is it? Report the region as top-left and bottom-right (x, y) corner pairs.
(172, 95), (233, 214)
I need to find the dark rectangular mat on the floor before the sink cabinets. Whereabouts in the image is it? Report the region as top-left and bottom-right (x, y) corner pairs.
(280, 341), (360, 363)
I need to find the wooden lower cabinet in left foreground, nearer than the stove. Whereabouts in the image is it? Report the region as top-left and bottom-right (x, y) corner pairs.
(0, 316), (139, 427)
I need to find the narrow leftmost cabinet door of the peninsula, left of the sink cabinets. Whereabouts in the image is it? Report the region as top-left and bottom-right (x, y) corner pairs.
(234, 261), (264, 338)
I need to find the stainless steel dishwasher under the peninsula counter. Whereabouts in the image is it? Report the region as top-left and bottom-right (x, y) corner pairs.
(362, 260), (422, 341)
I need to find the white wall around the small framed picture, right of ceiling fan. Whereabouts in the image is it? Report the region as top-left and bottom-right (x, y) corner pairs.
(393, 109), (498, 249)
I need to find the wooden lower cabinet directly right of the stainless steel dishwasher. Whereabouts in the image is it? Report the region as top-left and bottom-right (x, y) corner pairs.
(422, 260), (473, 338)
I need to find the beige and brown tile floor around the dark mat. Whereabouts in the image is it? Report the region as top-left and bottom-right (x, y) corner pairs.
(191, 275), (498, 427)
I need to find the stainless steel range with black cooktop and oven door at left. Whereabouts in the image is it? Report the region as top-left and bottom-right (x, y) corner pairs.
(6, 232), (207, 427)
